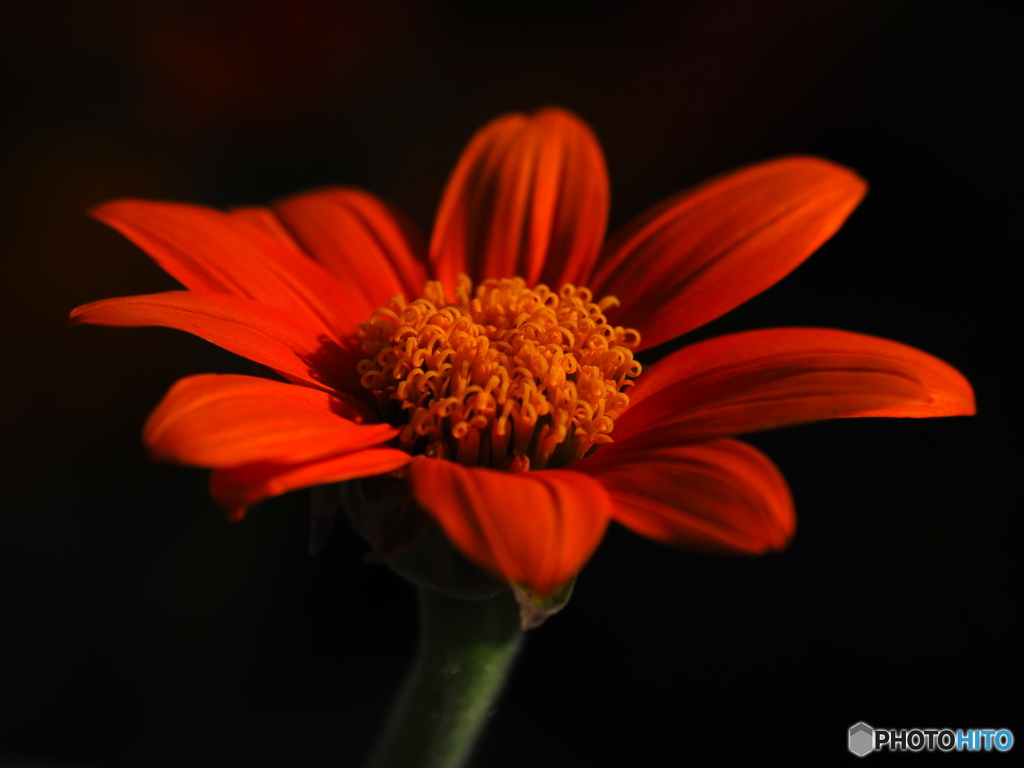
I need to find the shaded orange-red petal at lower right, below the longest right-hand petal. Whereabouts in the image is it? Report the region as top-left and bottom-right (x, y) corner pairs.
(571, 438), (797, 554)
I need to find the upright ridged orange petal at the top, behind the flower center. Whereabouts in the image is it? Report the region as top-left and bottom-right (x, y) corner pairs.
(430, 109), (608, 290)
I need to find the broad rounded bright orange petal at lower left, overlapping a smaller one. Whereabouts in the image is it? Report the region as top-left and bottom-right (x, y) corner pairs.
(142, 374), (398, 467)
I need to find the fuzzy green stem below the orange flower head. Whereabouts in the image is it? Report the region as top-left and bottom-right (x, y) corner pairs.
(367, 587), (522, 768)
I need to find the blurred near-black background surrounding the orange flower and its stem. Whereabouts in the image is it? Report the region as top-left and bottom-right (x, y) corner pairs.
(0, 0), (1024, 768)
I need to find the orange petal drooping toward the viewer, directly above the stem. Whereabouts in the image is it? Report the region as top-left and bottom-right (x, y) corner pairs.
(408, 459), (611, 594)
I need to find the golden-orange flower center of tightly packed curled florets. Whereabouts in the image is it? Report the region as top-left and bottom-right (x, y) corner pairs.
(357, 275), (640, 472)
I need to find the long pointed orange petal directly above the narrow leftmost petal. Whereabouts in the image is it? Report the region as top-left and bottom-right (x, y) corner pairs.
(92, 200), (366, 341)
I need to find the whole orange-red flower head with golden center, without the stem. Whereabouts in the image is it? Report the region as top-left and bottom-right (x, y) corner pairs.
(72, 110), (974, 594)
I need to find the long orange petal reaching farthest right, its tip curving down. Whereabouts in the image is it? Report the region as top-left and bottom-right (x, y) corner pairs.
(614, 328), (974, 441)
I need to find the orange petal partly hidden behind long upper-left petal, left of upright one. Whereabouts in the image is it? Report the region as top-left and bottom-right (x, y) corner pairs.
(273, 189), (427, 319)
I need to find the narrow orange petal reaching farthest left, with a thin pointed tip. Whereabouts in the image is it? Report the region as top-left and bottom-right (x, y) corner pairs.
(71, 291), (359, 392)
